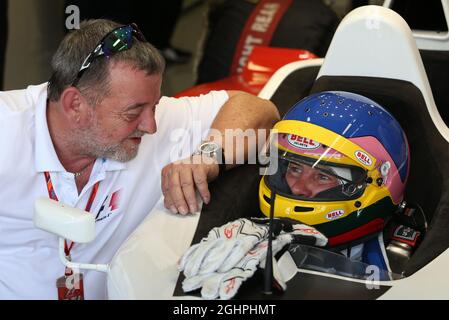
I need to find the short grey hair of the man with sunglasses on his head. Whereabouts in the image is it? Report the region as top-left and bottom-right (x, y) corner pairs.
(48, 19), (165, 105)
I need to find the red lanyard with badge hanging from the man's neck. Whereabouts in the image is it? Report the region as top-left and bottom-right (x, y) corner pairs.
(45, 172), (100, 300)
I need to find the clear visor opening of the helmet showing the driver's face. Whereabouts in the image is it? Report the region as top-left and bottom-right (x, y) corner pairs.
(265, 134), (367, 201)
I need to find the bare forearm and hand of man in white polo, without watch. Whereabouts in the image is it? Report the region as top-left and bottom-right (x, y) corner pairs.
(161, 91), (279, 214)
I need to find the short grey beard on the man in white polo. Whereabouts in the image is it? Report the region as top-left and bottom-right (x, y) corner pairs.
(73, 123), (146, 162)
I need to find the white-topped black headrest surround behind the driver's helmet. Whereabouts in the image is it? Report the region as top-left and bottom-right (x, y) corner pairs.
(261, 6), (449, 282)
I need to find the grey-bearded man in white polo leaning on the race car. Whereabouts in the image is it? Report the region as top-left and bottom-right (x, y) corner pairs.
(0, 20), (278, 299)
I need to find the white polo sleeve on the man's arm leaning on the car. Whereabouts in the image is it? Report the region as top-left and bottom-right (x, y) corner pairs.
(156, 91), (229, 160)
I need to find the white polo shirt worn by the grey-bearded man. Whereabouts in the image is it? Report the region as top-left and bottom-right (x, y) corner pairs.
(0, 84), (228, 299)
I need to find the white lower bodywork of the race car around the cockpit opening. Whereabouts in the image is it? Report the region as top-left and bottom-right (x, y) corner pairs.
(108, 199), (449, 300)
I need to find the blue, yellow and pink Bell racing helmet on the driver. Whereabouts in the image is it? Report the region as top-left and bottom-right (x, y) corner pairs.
(259, 91), (410, 247)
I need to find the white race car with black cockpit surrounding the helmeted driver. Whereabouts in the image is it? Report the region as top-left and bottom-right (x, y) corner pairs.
(108, 6), (449, 299)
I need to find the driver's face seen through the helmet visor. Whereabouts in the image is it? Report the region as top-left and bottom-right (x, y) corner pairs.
(285, 163), (340, 198)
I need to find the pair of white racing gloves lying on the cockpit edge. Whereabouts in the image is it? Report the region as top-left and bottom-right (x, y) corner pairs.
(179, 219), (327, 299)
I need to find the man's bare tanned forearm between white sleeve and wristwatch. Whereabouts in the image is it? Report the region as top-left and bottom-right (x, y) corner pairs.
(208, 91), (280, 168)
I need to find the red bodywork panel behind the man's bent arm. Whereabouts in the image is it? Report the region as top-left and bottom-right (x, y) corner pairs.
(176, 46), (318, 97)
